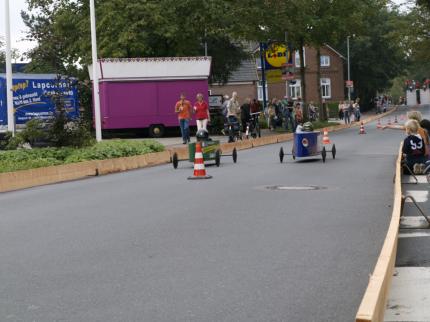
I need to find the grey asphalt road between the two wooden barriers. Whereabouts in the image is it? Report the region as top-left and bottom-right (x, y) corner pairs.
(0, 109), (416, 322)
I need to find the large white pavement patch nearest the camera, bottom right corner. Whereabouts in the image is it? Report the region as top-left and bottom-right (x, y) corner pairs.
(384, 267), (430, 322)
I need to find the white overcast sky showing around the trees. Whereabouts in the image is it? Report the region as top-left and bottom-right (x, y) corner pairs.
(0, 0), (410, 60)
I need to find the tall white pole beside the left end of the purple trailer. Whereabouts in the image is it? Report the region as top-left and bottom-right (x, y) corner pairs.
(90, 0), (102, 142)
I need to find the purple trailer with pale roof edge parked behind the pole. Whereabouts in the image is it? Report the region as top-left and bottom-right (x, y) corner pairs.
(88, 57), (211, 137)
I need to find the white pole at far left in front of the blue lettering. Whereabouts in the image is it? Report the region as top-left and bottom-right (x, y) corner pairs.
(4, 0), (15, 136)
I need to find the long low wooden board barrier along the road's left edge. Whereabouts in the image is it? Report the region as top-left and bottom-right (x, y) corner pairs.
(0, 108), (396, 192)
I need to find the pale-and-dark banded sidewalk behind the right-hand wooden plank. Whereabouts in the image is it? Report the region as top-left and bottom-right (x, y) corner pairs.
(385, 175), (430, 322)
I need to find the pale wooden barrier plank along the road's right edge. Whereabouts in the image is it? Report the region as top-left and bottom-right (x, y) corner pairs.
(355, 145), (402, 322)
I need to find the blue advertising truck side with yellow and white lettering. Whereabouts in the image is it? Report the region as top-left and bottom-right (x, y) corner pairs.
(0, 73), (79, 132)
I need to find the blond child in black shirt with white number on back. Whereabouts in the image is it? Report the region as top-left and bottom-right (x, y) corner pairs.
(403, 120), (426, 174)
